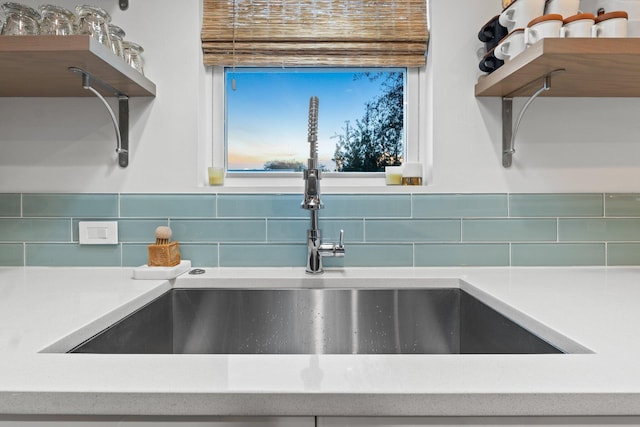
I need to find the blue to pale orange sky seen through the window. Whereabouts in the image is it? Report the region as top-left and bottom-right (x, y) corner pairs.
(225, 69), (404, 171)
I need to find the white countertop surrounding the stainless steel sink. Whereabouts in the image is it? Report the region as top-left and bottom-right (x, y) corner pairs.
(0, 267), (640, 416)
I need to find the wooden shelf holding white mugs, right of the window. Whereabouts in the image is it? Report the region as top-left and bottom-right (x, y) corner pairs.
(475, 38), (640, 97)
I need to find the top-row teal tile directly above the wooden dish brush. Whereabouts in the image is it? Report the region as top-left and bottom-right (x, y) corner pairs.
(120, 194), (216, 218)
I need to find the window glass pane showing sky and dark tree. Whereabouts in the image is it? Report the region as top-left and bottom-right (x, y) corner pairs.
(225, 68), (406, 172)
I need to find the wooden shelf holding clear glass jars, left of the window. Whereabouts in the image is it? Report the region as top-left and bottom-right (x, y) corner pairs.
(0, 35), (156, 97)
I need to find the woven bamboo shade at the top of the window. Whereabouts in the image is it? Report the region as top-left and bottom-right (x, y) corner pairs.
(202, 0), (429, 67)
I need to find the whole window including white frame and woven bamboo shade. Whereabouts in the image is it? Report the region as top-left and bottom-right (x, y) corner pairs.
(202, 0), (429, 186)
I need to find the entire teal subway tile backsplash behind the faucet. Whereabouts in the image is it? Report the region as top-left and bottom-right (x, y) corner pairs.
(0, 193), (640, 268)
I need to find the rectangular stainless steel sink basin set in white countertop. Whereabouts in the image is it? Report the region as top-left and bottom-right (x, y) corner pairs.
(70, 288), (563, 354)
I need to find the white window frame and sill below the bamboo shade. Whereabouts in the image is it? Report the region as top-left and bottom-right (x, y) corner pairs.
(205, 66), (428, 191)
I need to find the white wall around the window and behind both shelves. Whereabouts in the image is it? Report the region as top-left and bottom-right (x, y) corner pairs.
(0, 0), (640, 192)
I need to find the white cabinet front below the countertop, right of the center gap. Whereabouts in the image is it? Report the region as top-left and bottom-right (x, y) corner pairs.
(317, 417), (640, 427)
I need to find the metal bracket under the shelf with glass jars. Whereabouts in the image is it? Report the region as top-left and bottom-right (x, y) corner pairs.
(69, 67), (129, 168)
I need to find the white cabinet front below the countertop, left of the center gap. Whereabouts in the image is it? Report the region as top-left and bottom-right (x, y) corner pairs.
(0, 416), (315, 427)
